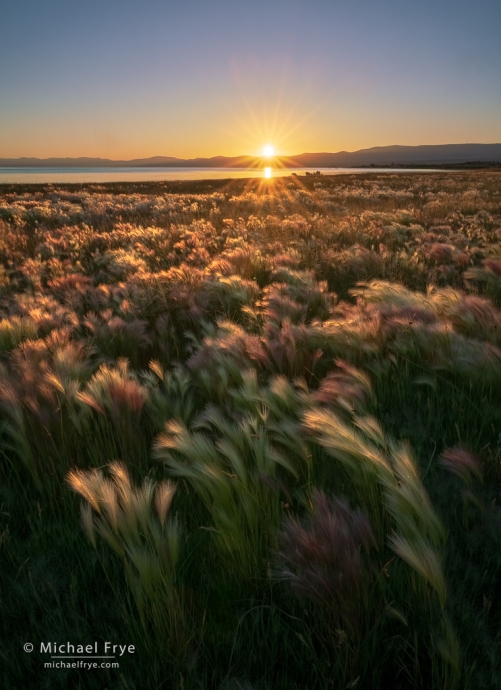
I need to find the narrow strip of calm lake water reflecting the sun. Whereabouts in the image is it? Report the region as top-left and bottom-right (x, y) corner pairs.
(0, 167), (440, 184)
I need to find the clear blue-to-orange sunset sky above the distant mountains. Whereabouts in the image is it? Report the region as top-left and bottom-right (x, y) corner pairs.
(0, 0), (501, 159)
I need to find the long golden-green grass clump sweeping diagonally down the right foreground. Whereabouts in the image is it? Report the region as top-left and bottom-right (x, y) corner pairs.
(303, 410), (460, 688)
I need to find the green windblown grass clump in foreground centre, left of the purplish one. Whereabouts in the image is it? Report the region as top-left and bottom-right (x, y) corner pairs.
(155, 409), (295, 581)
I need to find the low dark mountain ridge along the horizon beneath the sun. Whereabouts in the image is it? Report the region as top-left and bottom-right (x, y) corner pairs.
(0, 144), (501, 168)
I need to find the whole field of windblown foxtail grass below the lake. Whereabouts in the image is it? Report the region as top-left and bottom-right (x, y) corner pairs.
(0, 172), (501, 690)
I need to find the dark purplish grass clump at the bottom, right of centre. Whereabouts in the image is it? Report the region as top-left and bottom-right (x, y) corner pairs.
(278, 491), (381, 682)
